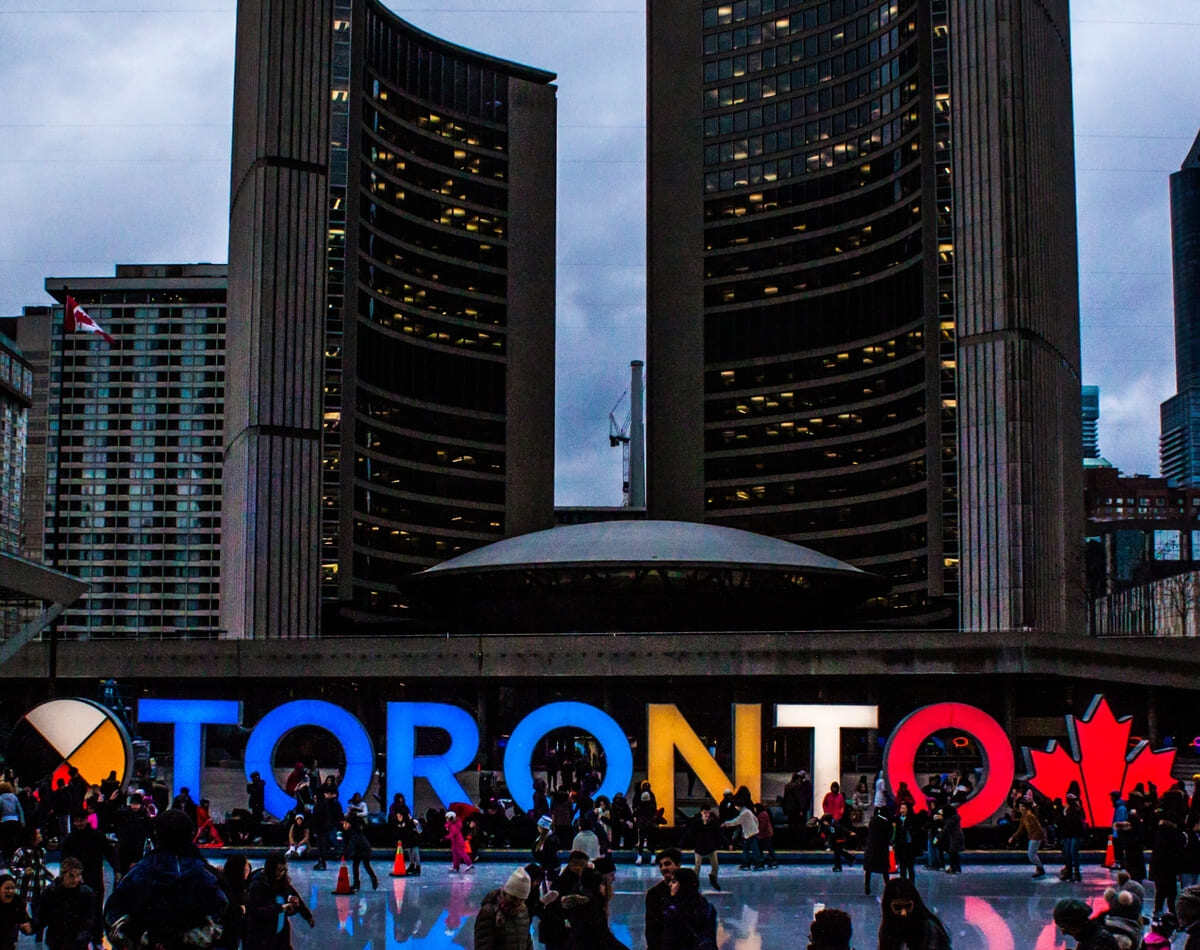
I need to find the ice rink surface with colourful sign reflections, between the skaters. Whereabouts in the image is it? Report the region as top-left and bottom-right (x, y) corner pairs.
(285, 864), (1108, 950)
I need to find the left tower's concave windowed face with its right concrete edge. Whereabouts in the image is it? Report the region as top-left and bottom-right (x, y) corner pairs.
(338, 2), (556, 614)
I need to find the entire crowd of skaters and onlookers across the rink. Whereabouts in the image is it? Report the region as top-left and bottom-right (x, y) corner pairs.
(0, 743), (1200, 950)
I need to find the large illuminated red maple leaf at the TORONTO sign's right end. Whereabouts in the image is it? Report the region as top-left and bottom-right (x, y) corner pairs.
(1022, 695), (1175, 826)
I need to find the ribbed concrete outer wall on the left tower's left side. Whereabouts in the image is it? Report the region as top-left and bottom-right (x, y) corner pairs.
(221, 0), (332, 638)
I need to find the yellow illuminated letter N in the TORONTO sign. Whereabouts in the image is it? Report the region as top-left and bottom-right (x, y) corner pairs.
(646, 703), (762, 824)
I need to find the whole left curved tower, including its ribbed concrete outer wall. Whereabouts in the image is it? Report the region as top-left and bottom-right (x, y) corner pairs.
(224, 0), (556, 636)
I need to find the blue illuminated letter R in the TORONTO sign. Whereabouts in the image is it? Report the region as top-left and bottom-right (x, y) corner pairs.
(388, 703), (479, 807)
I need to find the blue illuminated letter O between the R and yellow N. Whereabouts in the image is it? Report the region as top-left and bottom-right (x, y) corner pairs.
(504, 703), (634, 811)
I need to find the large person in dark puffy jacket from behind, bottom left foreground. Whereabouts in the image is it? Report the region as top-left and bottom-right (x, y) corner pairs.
(104, 808), (228, 946)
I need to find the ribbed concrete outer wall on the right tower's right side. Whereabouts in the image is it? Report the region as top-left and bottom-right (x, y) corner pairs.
(950, 0), (1084, 630)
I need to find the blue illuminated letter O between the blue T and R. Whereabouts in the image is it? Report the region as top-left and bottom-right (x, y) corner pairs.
(245, 699), (374, 818)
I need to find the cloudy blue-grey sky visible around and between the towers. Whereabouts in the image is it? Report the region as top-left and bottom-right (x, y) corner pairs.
(0, 0), (1200, 505)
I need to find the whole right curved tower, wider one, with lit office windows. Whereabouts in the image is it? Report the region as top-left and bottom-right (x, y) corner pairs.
(647, 0), (1080, 627)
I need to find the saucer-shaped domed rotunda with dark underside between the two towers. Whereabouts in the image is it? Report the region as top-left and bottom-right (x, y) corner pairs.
(406, 519), (887, 632)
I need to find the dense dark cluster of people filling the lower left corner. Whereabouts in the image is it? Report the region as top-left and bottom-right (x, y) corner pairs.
(0, 768), (313, 950)
